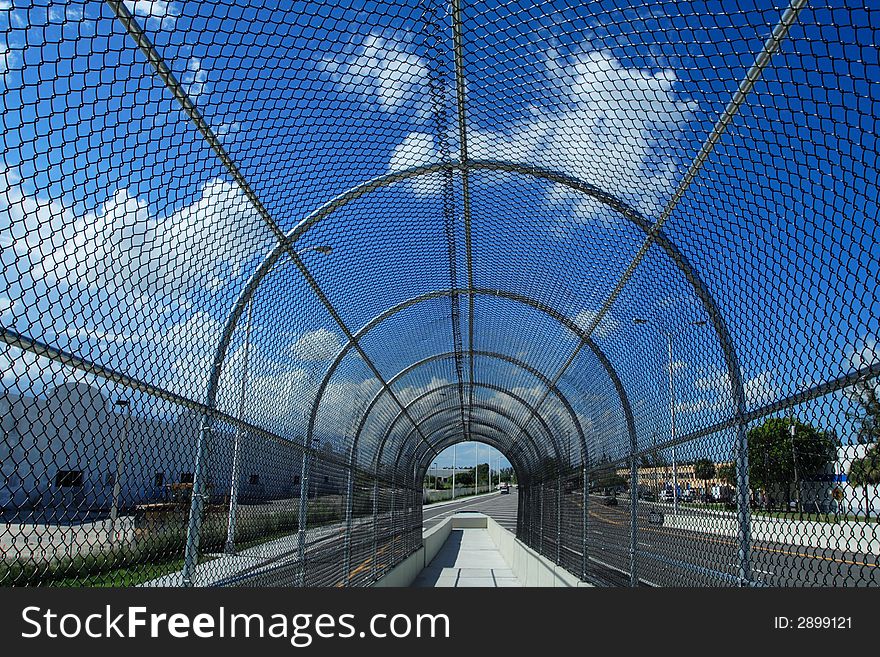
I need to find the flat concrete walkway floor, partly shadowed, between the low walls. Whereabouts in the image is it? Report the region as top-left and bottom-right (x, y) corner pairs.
(412, 529), (522, 588)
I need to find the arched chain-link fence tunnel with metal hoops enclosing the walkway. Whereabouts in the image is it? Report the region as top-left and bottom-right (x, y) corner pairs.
(0, 0), (880, 586)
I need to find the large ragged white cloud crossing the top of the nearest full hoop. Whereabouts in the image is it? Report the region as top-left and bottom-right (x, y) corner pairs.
(384, 49), (696, 221)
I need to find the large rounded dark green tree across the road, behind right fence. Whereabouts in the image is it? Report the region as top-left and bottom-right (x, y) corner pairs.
(748, 418), (837, 510)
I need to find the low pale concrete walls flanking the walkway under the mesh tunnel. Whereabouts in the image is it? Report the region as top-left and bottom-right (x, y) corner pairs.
(373, 513), (593, 588)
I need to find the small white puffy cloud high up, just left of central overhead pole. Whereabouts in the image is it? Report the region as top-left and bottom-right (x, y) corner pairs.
(323, 33), (428, 114)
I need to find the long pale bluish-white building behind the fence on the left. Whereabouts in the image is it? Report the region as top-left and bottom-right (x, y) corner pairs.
(0, 383), (344, 515)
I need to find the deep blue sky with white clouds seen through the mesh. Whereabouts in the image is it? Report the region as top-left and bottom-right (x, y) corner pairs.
(0, 0), (880, 472)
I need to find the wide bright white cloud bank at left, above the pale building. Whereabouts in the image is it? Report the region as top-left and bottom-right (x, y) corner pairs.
(12, 179), (271, 296)
